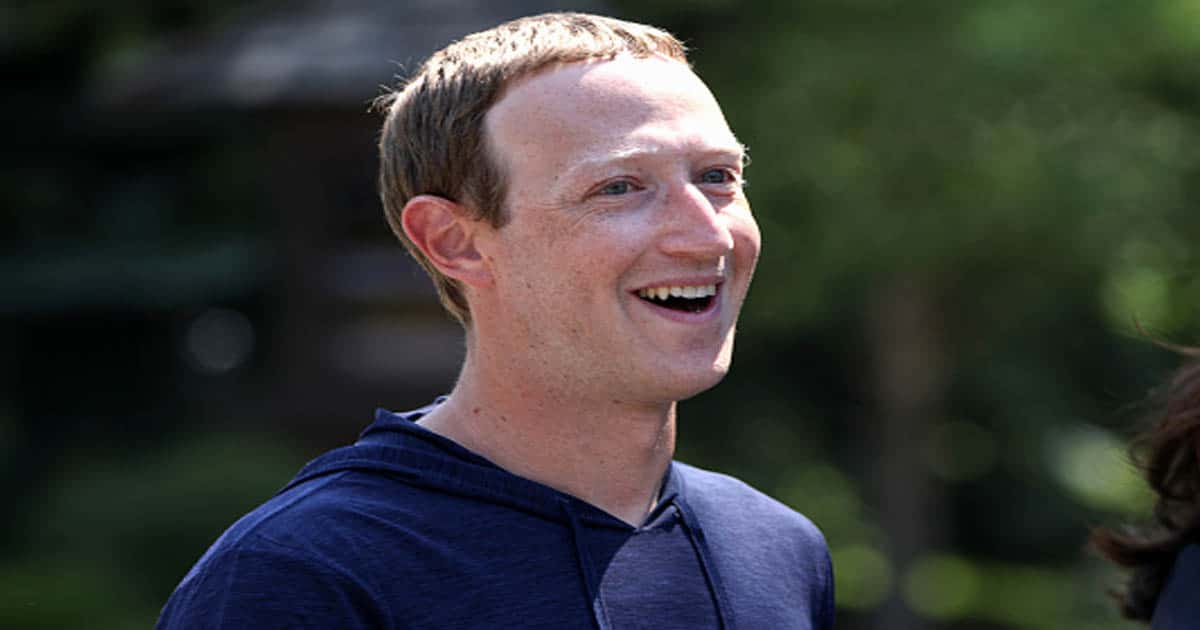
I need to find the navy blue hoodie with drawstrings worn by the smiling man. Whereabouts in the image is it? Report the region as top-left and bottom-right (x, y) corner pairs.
(157, 407), (834, 630)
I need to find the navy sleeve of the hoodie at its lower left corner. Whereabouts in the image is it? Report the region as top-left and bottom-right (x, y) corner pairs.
(155, 540), (386, 630)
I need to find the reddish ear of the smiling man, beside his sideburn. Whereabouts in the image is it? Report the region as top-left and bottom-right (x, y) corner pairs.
(400, 194), (492, 287)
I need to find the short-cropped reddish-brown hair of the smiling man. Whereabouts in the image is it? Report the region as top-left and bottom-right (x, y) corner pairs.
(377, 13), (688, 325)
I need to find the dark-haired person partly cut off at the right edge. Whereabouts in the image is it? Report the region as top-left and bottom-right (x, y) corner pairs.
(1091, 348), (1200, 630)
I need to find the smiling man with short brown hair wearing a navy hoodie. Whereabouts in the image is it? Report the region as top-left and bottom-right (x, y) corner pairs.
(160, 13), (833, 630)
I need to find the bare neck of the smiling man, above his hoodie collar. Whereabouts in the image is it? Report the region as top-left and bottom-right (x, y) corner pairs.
(420, 350), (676, 526)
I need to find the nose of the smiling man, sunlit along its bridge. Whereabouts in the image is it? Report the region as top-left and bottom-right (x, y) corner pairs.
(659, 182), (733, 260)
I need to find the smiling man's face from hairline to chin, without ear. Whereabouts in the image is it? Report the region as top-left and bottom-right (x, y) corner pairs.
(473, 58), (760, 403)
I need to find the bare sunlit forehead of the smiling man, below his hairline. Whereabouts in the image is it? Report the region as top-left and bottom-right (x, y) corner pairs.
(485, 56), (740, 175)
